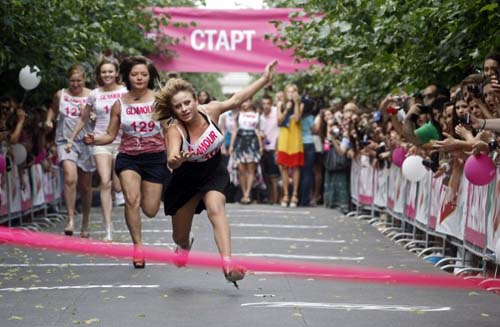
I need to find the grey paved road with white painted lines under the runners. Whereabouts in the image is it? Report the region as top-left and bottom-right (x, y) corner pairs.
(0, 204), (500, 327)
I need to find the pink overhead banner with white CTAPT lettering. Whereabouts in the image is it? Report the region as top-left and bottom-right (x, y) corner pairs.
(151, 8), (318, 73)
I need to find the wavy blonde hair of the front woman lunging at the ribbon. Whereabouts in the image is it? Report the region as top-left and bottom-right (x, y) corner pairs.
(153, 78), (196, 120)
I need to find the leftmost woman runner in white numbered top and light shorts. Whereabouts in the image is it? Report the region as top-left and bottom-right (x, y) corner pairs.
(45, 65), (95, 237)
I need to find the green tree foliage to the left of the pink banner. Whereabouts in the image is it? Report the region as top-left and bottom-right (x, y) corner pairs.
(0, 0), (194, 102)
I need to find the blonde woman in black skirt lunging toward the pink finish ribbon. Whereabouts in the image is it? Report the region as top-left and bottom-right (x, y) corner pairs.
(154, 60), (277, 287)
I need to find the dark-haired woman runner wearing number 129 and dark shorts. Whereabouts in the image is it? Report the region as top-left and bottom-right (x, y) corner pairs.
(85, 56), (168, 268)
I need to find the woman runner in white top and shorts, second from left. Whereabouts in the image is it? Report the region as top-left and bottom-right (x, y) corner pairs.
(65, 57), (127, 242)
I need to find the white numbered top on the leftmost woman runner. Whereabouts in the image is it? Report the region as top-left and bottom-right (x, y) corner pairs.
(56, 89), (91, 142)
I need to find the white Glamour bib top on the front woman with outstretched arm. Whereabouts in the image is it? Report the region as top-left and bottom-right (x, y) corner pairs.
(175, 106), (224, 162)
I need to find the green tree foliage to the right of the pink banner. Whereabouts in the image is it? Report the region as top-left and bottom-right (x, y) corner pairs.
(267, 0), (500, 103)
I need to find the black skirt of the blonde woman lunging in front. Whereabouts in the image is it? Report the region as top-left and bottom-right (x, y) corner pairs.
(163, 151), (229, 216)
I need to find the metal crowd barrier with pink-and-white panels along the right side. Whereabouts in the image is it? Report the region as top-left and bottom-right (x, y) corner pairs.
(347, 156), (500, 291)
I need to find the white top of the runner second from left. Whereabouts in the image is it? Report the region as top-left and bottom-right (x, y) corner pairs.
(87, 86), (127, 139)
